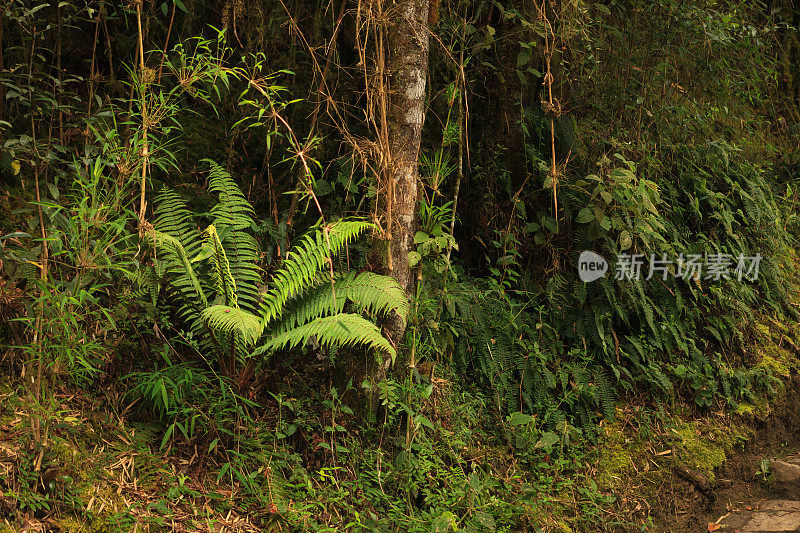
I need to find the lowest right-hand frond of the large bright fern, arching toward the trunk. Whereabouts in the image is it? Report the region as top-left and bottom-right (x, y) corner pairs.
(253, 313), (397, 360)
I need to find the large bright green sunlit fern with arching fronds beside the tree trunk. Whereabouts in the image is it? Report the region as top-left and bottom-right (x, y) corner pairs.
(151, 162), (408, 385)
